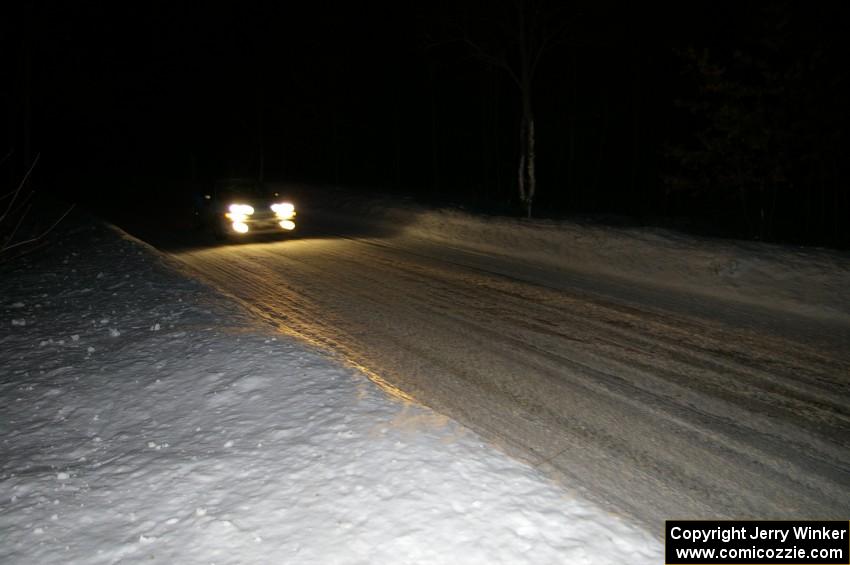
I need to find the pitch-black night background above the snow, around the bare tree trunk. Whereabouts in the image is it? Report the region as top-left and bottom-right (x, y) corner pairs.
(0, 0), (850, 246)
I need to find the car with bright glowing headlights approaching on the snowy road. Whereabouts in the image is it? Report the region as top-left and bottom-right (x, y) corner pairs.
(202, 179), (297, 238)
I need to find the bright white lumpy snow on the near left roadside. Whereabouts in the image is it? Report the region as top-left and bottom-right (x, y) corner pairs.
(0, 216), (662, 564)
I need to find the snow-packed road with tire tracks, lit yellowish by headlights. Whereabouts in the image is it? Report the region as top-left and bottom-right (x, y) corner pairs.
(166, 218), (850, 535)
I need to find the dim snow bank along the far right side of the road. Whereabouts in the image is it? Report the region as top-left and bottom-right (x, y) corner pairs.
(310, 189), (850, 320)
